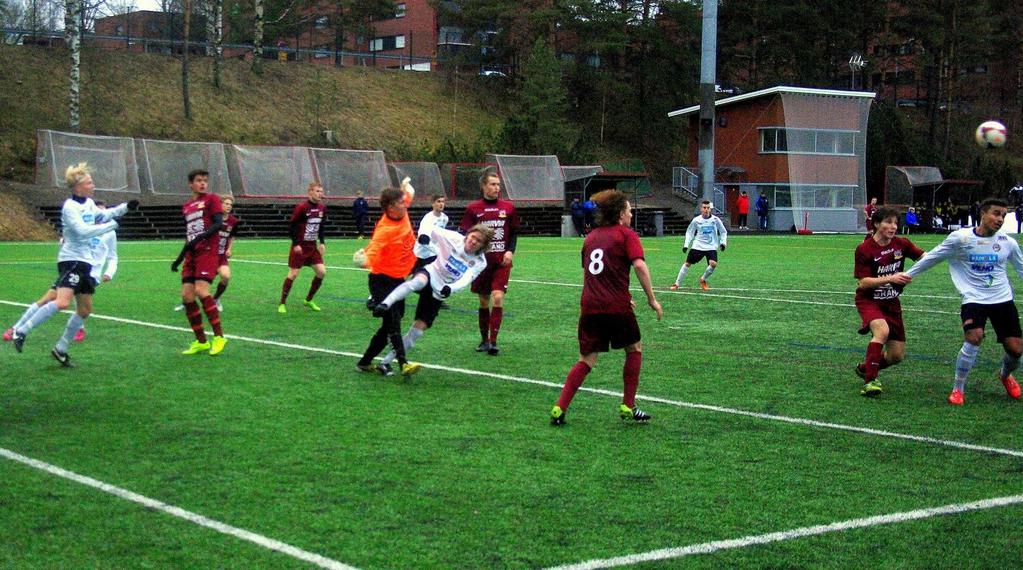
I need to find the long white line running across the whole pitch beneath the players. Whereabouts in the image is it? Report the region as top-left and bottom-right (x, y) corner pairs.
(0, 300), (1023, 457)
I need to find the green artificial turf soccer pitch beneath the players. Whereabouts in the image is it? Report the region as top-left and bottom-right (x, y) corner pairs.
(0, 234), (1023, 568)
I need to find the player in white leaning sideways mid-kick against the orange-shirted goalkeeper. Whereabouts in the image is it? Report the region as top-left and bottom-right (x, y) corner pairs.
(373, 224), (494, 376)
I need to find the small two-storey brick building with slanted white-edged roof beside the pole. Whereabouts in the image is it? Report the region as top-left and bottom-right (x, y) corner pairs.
(668, 86), (875, 232)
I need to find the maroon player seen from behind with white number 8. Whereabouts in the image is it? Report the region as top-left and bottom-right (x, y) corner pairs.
(550, 190), (664, 426)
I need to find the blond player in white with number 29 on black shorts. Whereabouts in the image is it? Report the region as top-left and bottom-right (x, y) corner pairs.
(11, 163), (138, 366)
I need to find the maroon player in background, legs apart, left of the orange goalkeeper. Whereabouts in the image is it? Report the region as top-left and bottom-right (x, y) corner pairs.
(277, 182), (326, 314)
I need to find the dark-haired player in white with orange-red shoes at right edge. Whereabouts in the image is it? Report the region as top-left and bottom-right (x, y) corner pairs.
(907, 199), (1023, 405)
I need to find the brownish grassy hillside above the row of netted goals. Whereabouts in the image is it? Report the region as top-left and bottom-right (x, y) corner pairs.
(0, 46), (503, 181)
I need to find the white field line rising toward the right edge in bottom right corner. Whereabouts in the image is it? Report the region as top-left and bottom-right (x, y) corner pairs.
(549, 495), (1023, 570)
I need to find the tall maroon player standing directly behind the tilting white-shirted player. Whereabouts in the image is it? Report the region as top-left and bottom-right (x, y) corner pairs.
(459, 170), (519, 356)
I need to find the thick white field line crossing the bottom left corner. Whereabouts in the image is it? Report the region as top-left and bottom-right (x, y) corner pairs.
(0, 447), (354, 570)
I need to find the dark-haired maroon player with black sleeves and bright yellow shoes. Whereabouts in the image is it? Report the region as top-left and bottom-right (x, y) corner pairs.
(171, 170), (227, 356)
